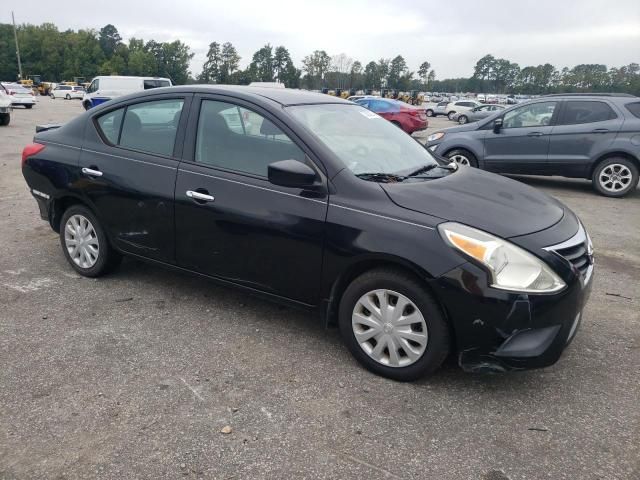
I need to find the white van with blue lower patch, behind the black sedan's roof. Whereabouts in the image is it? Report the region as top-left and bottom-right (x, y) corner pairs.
(82, 75), (172, 110)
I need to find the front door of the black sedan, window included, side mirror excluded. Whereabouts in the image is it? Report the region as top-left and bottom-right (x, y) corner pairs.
(175, 96), (328, 304)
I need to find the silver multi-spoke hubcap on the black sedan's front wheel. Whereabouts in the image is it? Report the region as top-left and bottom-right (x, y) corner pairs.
(351, 290), (428, 367)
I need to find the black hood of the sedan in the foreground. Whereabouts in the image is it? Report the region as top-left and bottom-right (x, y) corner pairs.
(380, 167), (564, 238)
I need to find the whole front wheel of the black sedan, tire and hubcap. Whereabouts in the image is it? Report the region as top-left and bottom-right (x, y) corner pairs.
(339, 269), (450, 381)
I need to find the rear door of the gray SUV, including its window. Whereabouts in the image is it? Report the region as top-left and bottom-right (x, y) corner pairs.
(546, 99), (622, 177)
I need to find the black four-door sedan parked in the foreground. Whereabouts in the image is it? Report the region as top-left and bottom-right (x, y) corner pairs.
(22, 86), (593, 380)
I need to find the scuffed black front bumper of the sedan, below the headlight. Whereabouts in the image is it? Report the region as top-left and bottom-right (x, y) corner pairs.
(432, 223), (593, 372)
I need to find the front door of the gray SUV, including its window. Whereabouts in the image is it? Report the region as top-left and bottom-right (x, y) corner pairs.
(484, 101), (558, 174)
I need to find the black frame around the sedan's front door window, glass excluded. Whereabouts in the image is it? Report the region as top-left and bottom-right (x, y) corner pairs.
(180, 93), (327, 179)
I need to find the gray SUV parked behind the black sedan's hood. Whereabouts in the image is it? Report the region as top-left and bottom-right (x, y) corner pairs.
(426, 94), (640, 197)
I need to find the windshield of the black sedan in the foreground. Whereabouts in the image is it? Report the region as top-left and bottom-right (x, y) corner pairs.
(287, 104), (437, 174)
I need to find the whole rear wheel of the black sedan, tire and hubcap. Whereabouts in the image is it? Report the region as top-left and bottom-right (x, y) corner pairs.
(60, 205), (121, 277)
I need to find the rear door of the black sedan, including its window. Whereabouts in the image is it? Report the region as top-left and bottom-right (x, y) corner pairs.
(79, 94), (191, 263)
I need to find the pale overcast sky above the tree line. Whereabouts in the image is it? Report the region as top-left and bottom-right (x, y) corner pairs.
(6, 0), (640, 79)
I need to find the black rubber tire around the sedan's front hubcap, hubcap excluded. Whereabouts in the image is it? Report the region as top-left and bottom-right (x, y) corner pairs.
(338, 270), (450, 381)
